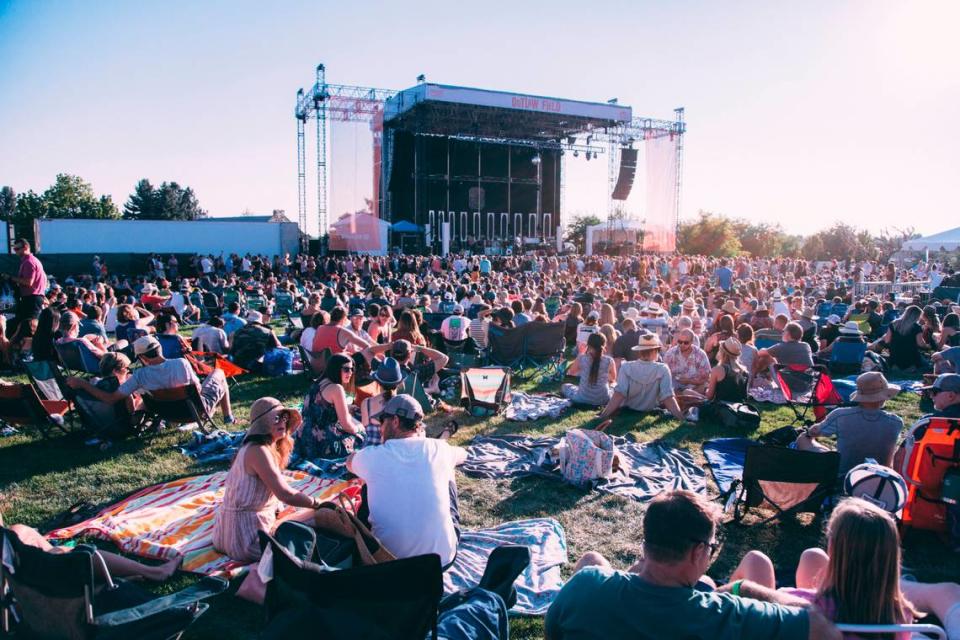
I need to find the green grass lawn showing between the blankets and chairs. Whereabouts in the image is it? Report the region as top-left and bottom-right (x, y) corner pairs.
(0, 368), (960, 638)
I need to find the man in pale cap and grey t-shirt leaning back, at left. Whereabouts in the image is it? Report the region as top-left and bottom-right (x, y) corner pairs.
(67, 336), (234, 424)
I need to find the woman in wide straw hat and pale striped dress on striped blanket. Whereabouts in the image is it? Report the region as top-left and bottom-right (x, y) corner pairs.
(213, 398), (319, 562)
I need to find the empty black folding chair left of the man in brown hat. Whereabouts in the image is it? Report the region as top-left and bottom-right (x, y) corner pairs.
(726, 445), (840, 524)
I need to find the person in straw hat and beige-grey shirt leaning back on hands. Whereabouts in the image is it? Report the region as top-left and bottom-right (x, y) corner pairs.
(600, 334), (683, 420)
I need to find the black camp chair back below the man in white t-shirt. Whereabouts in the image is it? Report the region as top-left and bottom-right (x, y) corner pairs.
(261, 538), (443, 640)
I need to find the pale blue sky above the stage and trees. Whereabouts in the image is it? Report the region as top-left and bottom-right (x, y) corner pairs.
(0, 0), (960, 238)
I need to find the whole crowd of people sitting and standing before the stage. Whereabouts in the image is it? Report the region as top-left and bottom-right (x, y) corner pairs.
(0, 240), (960, 640)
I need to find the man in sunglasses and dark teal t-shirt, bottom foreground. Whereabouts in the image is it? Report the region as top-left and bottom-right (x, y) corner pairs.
(544, 490), (841, 640)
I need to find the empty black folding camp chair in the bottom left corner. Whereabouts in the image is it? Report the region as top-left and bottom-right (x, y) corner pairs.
(0, 529), (228, 640)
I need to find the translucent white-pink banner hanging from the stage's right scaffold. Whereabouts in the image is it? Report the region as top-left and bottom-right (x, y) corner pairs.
(643, 134), (677, 252)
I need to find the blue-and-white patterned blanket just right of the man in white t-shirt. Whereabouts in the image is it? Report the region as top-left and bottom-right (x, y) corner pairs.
(443, 518), (567, 615)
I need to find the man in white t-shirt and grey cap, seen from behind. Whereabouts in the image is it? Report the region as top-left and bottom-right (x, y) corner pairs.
(347, 394), (467, 566)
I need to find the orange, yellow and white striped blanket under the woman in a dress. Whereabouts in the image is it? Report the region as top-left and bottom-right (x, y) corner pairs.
(47, 471), (360, 577)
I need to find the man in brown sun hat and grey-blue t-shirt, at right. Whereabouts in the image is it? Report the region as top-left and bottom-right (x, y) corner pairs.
(797, 371), (903, 476)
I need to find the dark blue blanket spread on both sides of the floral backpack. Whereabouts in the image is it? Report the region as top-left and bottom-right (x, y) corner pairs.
(460, 436), (706, 502)
